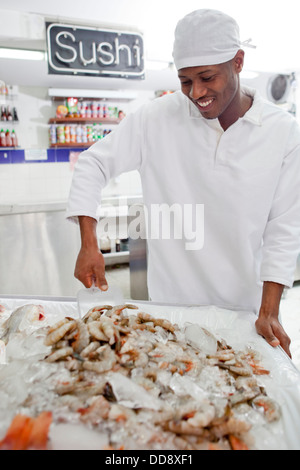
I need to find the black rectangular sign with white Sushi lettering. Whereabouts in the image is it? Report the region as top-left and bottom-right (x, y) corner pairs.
(46, 23), (145, 79)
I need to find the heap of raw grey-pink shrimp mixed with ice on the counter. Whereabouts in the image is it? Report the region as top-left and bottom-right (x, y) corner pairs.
(39, 304), (280, 450)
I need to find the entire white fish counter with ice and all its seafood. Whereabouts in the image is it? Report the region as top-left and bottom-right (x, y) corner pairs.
(0, 296), (300, 451)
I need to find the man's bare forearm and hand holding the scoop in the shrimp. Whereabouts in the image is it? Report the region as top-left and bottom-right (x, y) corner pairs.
(74, 216), (108, 290)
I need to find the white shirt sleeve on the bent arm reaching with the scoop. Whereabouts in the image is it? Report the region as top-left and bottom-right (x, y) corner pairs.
(66, 107), (143, 223)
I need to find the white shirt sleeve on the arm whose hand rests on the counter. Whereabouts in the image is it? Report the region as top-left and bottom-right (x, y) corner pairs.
(261, 122), (300, 287)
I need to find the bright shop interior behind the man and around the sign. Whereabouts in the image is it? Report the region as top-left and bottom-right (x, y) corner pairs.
(0, 0), (300, 368)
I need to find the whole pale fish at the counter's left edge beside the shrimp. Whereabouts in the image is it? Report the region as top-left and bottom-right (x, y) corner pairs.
(0, 304), (45, 344)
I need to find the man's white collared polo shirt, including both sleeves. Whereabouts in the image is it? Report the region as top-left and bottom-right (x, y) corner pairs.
(67, 89), (300, 312)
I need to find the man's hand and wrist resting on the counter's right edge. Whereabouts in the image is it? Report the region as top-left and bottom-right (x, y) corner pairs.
(255, 282), (291, 357)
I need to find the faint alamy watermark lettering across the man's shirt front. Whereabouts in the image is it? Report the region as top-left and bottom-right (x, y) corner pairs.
(98, 203), (204, 250)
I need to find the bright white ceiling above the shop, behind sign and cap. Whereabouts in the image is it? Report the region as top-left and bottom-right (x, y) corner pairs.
(0, 0), (300, 89)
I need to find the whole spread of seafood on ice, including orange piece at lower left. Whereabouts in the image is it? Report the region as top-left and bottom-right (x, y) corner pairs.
(0, 304), (281, 450)
